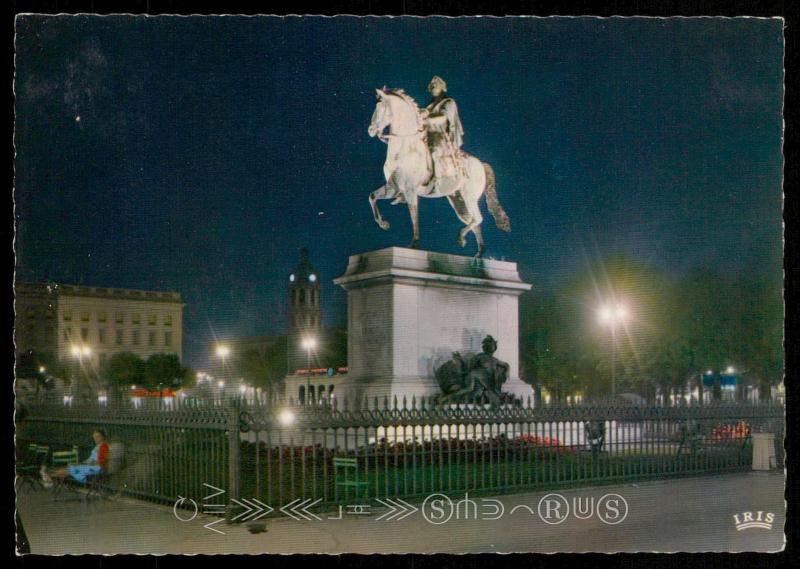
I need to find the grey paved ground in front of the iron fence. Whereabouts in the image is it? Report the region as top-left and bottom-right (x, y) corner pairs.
(17, 472), (785, 554)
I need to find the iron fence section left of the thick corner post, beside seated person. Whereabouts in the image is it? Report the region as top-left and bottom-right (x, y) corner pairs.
(16, 405), (231, 502)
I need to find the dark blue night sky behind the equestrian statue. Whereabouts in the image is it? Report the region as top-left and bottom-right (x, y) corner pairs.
(15, 16), (783, 365)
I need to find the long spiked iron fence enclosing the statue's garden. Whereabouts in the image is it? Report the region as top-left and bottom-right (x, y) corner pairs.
(17, 399), (784, 509)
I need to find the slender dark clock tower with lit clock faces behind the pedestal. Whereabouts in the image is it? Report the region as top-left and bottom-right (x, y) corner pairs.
(287, 247), (323, 374)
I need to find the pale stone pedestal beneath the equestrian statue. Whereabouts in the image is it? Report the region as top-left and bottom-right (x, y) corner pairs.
(333, 247), (531, 399)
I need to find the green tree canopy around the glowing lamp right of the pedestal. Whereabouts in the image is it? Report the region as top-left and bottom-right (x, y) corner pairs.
(520, 255), (783, 400)
